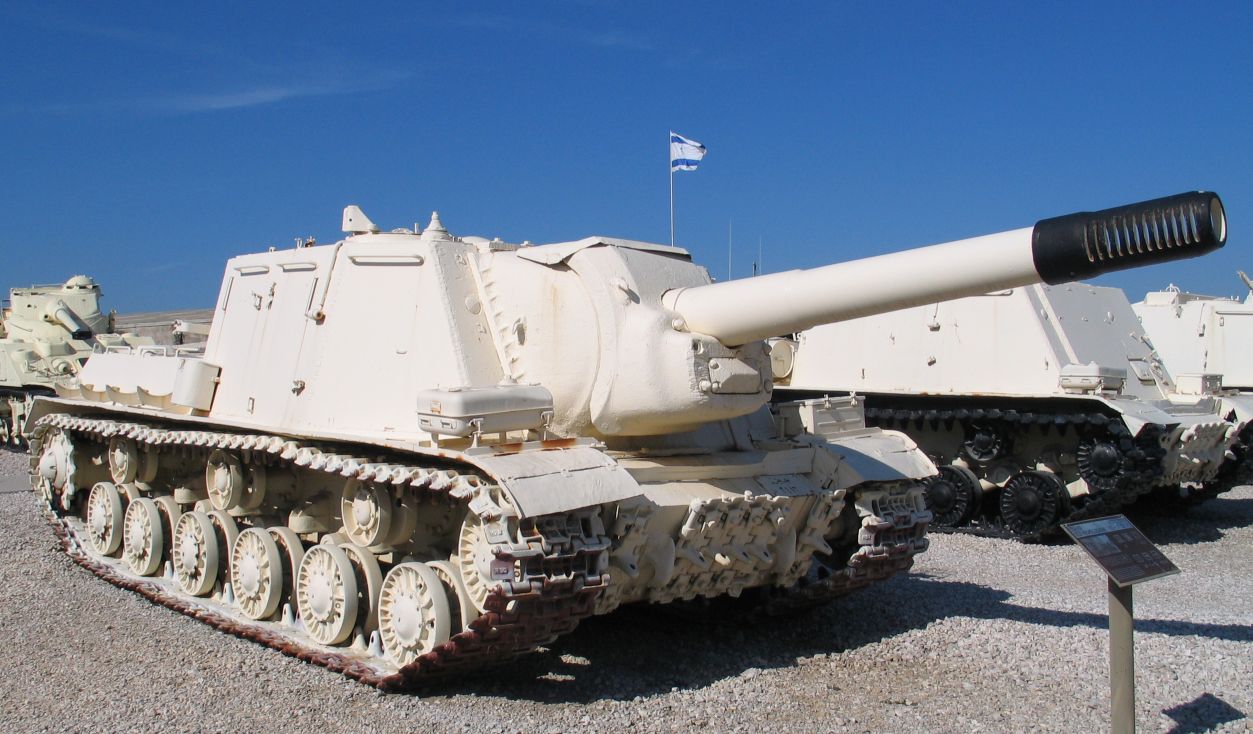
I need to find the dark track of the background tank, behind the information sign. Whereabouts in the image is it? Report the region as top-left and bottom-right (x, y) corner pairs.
(866, 407), (1165, 542)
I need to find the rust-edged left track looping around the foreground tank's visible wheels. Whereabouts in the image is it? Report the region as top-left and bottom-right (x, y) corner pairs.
(30, 415), (609, 691)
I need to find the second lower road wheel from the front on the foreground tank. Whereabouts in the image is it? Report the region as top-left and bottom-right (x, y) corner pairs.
(296, 545), (357, 645)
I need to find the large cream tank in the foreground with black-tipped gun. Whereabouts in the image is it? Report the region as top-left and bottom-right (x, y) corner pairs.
(29, 190), (1222, 689)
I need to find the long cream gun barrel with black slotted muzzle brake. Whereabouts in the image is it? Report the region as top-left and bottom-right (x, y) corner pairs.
(663, 192), (1227, 346)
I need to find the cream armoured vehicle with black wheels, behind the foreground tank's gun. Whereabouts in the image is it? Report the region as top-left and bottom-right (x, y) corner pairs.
(774, 193), (1232, 540)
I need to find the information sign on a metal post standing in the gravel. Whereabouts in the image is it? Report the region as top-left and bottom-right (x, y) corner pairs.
(1061, 515), (1179, 734)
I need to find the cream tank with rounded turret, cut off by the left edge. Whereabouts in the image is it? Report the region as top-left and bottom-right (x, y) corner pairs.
(0, 276), (152, 445)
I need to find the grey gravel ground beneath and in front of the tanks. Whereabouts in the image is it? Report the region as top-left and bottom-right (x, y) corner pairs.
(0, 452), (1253, 733)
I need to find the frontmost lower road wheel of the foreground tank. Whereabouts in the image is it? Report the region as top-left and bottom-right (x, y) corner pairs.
(378, 562), (460, 665)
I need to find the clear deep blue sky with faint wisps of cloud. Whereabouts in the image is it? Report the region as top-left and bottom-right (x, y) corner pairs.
(0, 0), (1253, 312)
